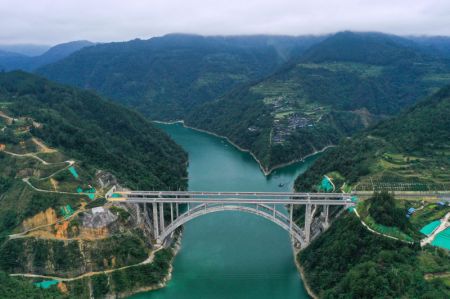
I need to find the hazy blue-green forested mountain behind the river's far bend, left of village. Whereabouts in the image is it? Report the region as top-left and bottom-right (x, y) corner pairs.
(38, 34), (323, 120)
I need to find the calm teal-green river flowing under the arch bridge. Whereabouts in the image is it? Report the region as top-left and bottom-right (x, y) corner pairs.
(132, 124), (315, 299)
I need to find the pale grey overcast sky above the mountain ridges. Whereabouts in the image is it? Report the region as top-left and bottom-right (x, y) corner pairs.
(0, 0), (450, 44)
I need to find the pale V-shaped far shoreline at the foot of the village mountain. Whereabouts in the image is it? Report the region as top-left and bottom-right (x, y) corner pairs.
(152, 120), (335, 176)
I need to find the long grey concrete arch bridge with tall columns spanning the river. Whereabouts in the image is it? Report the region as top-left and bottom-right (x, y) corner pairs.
(106, 191), (354, 248)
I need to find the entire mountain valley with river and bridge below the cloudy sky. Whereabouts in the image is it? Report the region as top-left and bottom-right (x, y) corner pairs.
(0, 31), (450, 299)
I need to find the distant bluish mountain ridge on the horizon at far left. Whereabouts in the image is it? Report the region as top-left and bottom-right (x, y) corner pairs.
(0, 41), (94, 71)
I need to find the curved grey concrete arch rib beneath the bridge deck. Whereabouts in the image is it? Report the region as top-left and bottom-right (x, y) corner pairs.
(157, 204), (307, 247)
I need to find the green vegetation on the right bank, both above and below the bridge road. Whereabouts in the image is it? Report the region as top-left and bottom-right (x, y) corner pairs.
(295, 87), (450, 298)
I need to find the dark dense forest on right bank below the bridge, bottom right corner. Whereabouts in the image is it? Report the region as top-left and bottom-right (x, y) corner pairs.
(298, 213), (450, 299)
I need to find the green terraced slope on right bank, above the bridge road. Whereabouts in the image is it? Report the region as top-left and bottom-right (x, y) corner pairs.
(295, 86), (450, 191)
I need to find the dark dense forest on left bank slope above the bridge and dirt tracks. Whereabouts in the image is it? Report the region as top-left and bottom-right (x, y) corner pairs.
(0, 72), (187, 189)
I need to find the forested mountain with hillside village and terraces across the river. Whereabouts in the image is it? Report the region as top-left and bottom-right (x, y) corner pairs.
(185, 32), (450, 170)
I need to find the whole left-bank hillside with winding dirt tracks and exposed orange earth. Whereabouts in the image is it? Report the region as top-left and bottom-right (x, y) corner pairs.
(0, 72), (187, 298)
